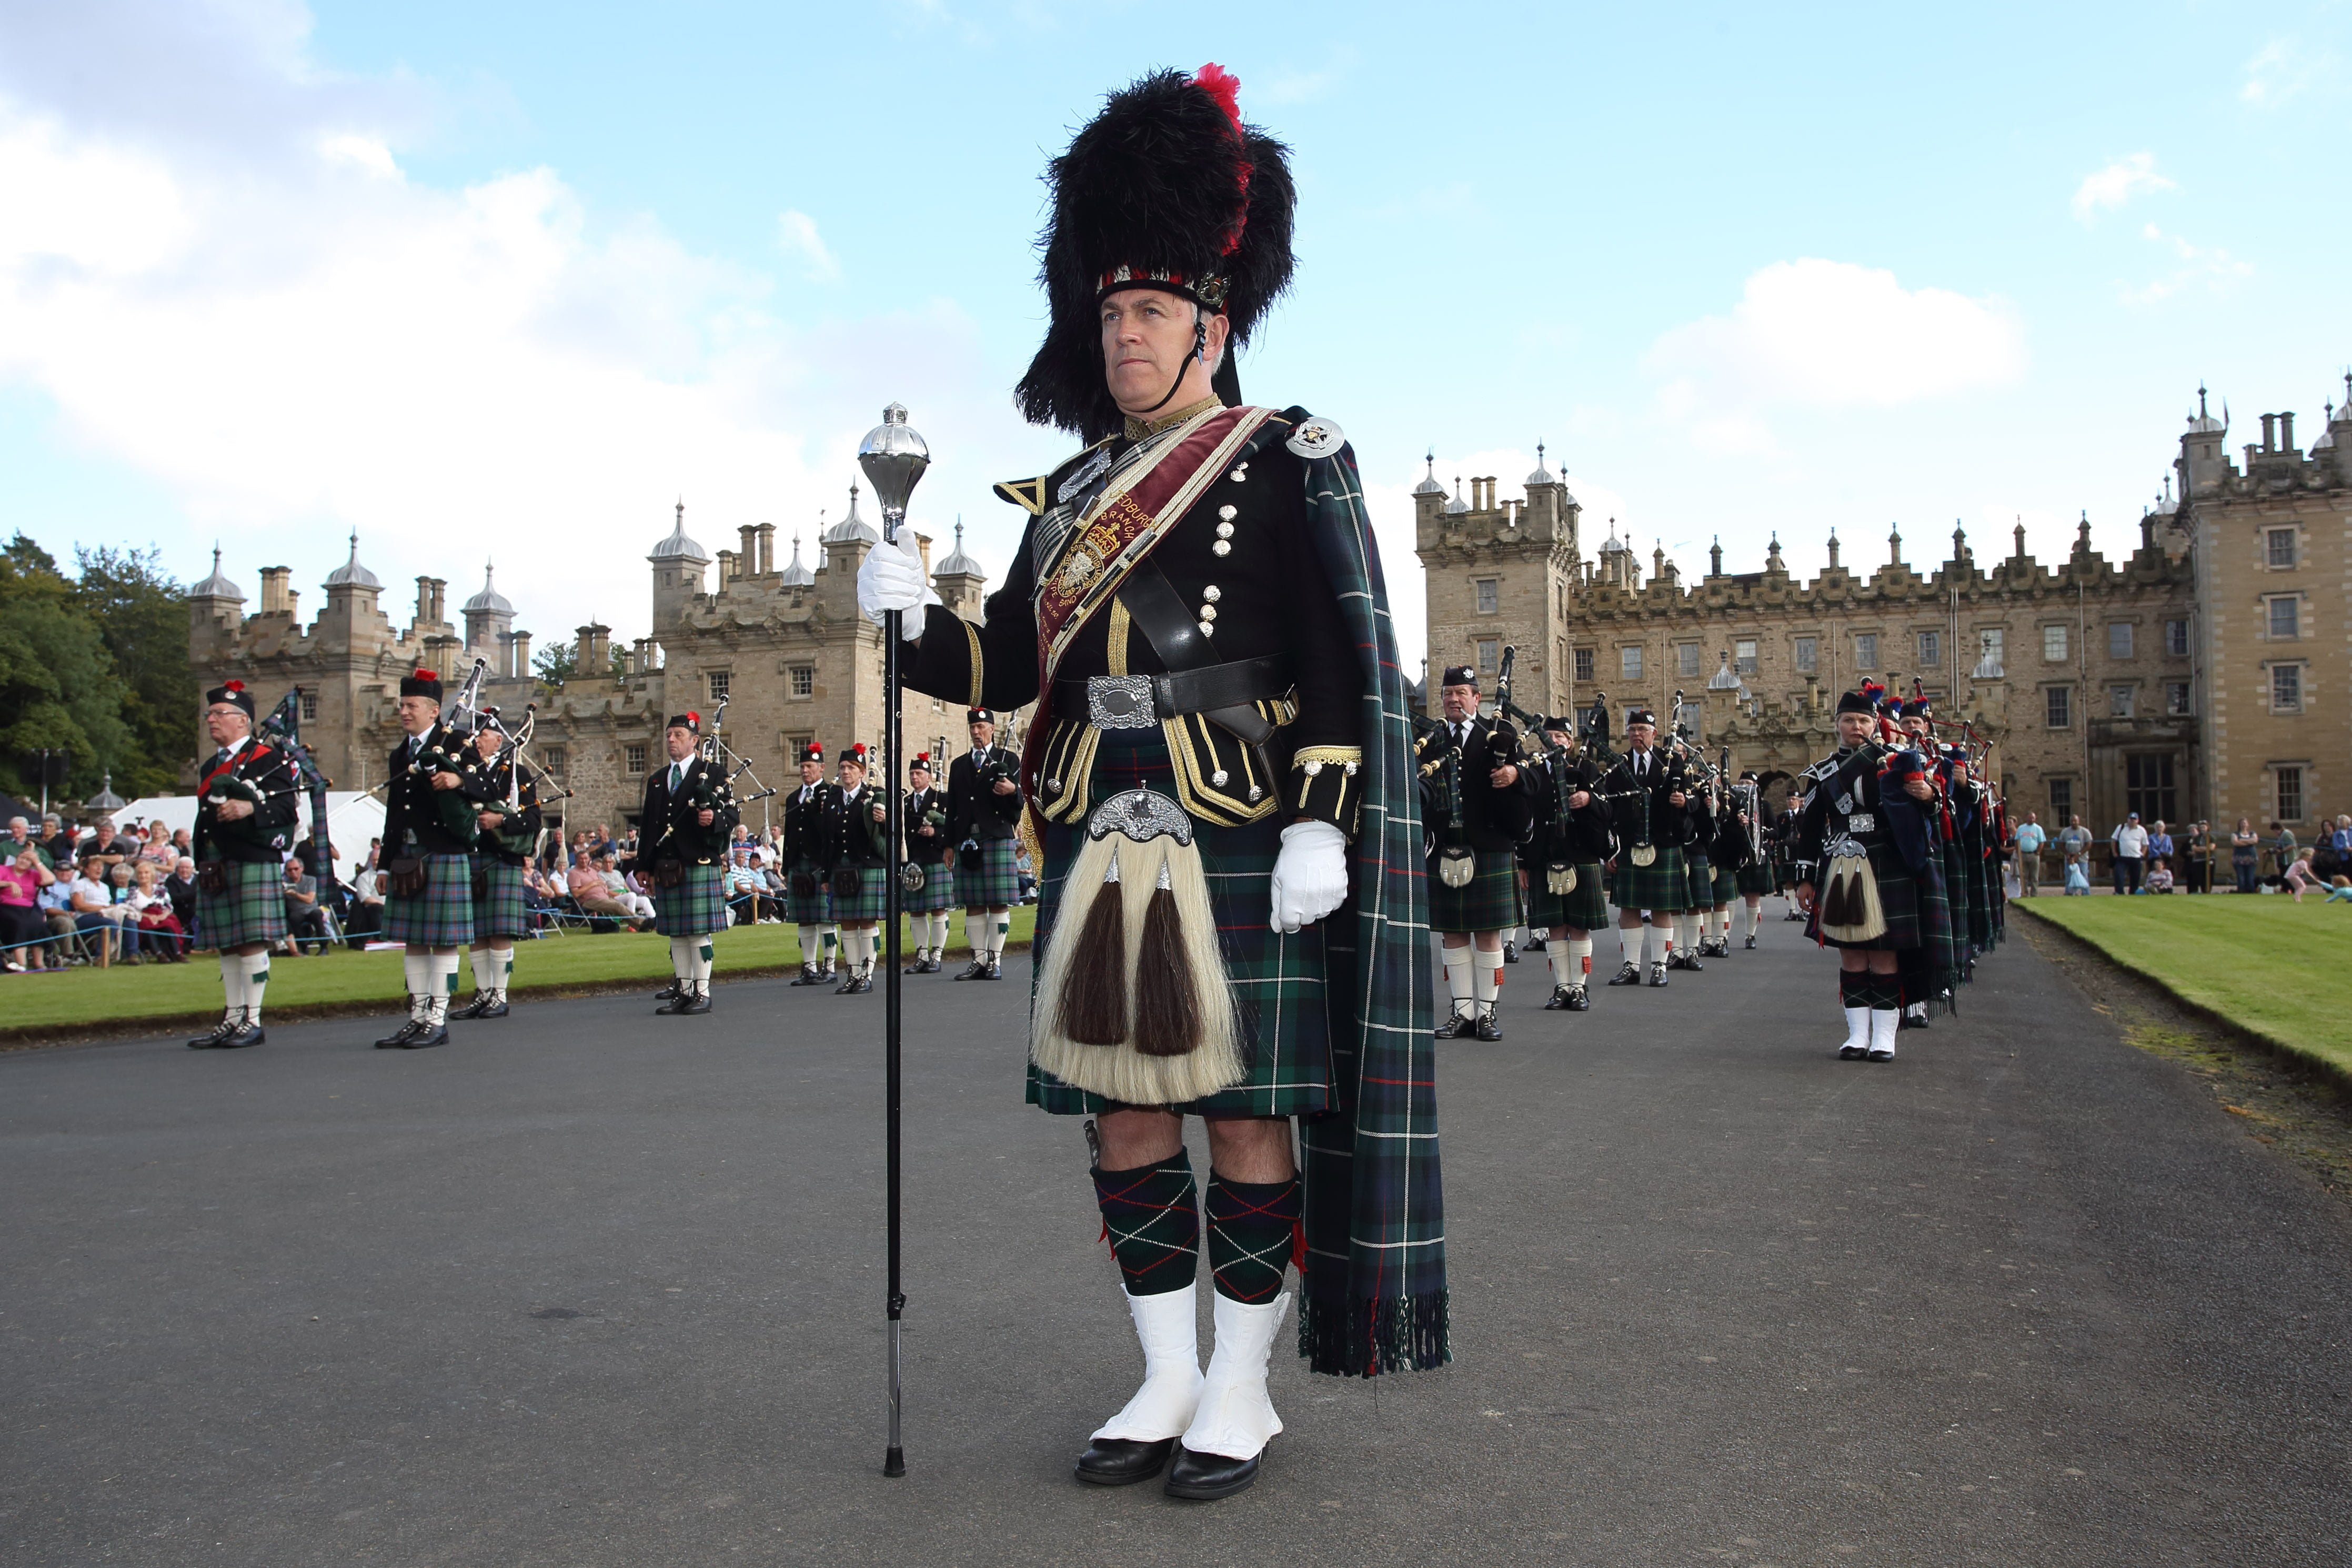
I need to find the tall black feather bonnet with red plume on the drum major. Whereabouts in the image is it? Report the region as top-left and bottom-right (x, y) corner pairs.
(1014, 64), (1298, 442)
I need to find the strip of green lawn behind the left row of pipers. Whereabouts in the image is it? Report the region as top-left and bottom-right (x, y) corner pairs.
(0, 908), (1037, 1041)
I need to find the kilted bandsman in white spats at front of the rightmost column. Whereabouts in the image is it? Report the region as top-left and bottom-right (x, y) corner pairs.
(1797, 682), (1943, 1062)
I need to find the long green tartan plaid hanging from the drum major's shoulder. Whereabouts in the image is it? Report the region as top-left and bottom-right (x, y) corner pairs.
(1258, 409), (1451, 1378)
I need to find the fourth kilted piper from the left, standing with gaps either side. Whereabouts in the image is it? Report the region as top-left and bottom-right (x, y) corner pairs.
(632, 710), (739, 1016)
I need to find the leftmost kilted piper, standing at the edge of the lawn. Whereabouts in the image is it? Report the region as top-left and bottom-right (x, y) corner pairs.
(188, 679), (301, 1051)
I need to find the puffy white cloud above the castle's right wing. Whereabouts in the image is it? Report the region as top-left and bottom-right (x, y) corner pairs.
(1646, 258), (2025, 420)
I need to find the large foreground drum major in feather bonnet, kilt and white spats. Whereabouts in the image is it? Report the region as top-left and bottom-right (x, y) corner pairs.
(859, 66), (1446, 1497)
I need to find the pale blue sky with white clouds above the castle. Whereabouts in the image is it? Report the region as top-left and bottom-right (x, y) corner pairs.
(0, 0), (2352, 662)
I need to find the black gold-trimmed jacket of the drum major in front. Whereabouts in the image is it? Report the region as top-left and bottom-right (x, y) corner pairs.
(906, 409), (1364, 844)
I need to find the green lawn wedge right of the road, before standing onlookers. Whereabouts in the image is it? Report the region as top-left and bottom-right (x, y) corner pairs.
(2008, 893), (2352, 1077)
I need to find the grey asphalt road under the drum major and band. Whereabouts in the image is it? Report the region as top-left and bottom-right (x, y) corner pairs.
(0, 921), (2352, 1568)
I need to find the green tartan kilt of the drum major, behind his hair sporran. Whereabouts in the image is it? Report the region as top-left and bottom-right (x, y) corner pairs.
(1028, 724), (1355, 1117)
